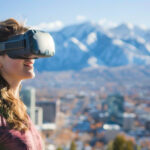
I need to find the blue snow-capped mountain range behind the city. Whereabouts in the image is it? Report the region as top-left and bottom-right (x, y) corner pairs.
(35, 22), (150, 71)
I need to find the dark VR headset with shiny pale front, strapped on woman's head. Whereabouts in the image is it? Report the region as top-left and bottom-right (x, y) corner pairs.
(0, 30), (55, 59)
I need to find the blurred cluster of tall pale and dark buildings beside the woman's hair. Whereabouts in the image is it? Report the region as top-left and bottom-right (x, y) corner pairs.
(20, 87), (59, 129)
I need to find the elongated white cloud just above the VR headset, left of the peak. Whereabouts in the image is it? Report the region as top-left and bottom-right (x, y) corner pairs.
(31, 20), (64, 31)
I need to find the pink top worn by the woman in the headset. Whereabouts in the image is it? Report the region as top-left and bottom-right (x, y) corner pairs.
(0, 116), (42, 150)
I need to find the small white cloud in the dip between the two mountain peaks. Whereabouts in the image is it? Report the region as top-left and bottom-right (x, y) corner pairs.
(98, 18), (118, 28)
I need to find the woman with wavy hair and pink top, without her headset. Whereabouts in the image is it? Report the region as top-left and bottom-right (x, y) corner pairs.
(0, 18), (42, 150)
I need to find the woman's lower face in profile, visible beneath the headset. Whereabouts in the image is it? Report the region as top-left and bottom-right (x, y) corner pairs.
(0, 54), (35, 81)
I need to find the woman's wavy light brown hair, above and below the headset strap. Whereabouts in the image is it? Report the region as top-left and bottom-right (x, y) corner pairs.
(0, 18), (29, 132)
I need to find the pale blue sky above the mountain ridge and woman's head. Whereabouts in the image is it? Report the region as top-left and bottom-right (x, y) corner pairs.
(0, 0), (150, 29)
